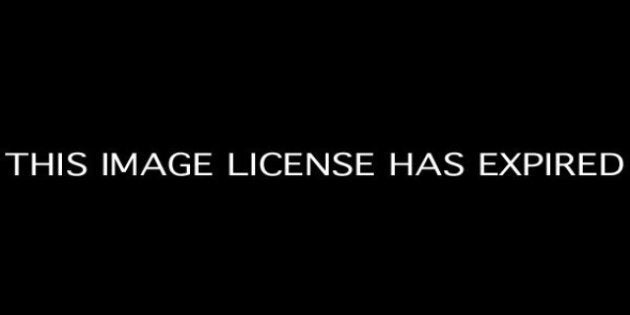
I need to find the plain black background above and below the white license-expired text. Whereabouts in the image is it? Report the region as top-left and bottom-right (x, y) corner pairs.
(0, 7), (628, 309)
